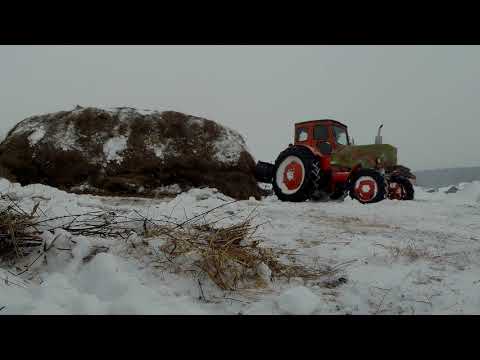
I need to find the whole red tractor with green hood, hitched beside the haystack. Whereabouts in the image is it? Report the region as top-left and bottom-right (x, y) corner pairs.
(255, 119), (415, 204)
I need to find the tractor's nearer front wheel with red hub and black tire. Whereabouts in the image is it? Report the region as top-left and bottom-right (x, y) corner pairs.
(349, 169), (387, 204)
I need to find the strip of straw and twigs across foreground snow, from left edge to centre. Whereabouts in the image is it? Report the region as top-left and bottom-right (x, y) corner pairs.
(0, 195), (334, 290)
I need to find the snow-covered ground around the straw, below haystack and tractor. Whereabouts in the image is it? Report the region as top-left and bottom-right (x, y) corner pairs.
(0, 179), (480, 314)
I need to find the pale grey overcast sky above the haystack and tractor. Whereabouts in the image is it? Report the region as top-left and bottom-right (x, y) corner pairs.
(0, 46), (480, 170)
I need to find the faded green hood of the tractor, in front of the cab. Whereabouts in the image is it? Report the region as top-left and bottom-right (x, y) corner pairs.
(331, 144), (397, 168)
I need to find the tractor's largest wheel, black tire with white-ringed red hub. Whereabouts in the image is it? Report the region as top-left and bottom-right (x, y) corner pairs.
(272, 146), (320, 202)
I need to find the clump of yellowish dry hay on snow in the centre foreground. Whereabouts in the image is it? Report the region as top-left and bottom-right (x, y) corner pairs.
(147, 212), (332, 291)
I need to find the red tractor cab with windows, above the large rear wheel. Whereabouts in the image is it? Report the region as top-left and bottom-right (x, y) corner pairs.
(295, 119), (350, 153)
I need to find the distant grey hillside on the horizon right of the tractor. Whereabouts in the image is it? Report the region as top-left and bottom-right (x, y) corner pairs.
(414, 167), (480, 188)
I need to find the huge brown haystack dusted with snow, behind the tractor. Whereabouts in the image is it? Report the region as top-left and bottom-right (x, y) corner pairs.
(0, 106), (260, 199)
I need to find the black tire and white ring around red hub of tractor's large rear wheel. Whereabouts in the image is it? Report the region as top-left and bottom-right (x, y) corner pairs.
(272, 146), (320, 202)
